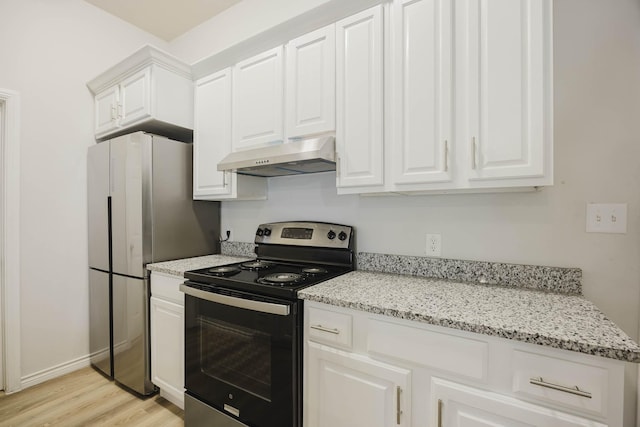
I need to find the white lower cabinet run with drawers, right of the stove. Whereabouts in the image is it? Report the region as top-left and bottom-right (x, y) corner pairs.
(303, 301), (636, 427)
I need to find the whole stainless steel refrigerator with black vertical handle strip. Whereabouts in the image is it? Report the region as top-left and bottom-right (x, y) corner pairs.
(87, 132), (220, 395)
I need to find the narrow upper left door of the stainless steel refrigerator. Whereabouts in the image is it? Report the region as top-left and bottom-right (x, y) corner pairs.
(87, 142), (109, 271)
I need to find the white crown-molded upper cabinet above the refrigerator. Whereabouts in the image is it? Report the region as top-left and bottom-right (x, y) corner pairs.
(87, 46), (193, 142)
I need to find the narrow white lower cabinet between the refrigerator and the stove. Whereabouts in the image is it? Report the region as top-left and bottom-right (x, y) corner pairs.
(150, 273), (184, 409)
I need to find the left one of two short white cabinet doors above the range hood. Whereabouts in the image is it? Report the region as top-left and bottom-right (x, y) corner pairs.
(232, 46), (284, 151)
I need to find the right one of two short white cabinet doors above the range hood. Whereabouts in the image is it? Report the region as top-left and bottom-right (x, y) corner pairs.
(285, 25), (336, 138)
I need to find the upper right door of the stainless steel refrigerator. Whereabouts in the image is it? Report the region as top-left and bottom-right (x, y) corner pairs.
(110, 132), (152, 277)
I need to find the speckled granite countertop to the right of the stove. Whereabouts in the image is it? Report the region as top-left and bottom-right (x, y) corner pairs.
(298, 271), (640, 363)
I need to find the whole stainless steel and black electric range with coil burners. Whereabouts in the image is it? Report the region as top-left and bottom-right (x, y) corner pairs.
(181, 221), (355, 427)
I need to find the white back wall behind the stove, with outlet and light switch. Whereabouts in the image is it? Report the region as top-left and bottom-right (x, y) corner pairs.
(171, 0), (640, 339)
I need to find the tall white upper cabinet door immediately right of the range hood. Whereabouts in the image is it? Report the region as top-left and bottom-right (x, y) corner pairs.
(336, 5), (384, 189)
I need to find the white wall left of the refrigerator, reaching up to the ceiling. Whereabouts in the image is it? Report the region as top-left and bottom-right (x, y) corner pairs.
(0, 0), (167, 379)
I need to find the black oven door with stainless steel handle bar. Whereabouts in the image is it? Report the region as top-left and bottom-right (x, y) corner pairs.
(181, 282), (302, 427)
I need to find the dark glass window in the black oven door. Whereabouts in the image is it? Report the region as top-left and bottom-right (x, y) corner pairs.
(198, 315), (272, 401)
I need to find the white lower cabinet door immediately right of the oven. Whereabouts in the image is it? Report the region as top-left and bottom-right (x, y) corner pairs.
(303, 342), (411, 427)
